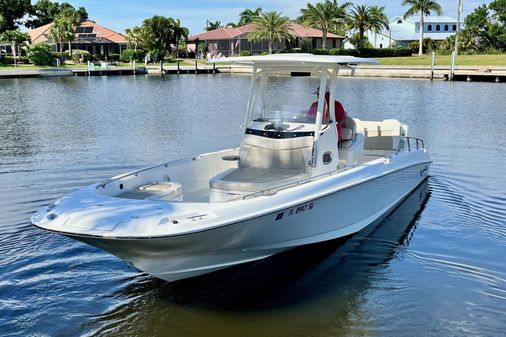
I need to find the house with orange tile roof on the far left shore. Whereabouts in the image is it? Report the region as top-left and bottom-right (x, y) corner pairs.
(28, 21), (127, 58)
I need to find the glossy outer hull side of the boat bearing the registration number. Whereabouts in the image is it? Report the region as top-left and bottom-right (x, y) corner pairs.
(64, 162), (429, 281)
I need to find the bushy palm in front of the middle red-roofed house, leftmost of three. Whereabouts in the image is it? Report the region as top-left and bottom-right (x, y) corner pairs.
(248, 11), (293, 54)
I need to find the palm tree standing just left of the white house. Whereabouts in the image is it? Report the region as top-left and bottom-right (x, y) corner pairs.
(351, 5), (388, 49)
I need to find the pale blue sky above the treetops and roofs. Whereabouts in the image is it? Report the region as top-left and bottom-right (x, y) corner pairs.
(60, 0), (489, 34)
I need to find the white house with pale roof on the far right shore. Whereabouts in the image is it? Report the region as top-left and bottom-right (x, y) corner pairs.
(348, 16), (463, 48)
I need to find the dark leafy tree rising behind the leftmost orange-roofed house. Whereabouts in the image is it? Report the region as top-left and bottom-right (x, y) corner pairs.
(25, 0), (88, 28)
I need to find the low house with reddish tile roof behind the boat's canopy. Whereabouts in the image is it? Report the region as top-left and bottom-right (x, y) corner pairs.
(188, 22), (344, 56)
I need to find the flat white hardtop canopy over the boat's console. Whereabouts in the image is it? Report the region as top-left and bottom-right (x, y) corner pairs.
(209, 53), (379, 66)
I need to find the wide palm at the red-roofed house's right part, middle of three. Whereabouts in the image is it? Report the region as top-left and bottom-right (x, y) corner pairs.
(300, 0), (351, 48)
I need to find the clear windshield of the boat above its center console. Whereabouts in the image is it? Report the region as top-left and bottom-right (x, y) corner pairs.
(248, 76), (326, 125)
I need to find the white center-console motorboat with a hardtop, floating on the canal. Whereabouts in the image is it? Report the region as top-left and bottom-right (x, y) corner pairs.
(31, 54), (431, 281)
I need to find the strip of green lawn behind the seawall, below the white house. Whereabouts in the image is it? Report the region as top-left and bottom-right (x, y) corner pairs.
(377, 54), (506, 67)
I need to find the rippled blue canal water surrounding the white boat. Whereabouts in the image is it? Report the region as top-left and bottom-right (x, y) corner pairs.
(0, 75), (506, 336)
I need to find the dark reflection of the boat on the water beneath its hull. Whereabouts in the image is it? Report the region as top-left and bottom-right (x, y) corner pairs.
(87, 181), (430, 336)
